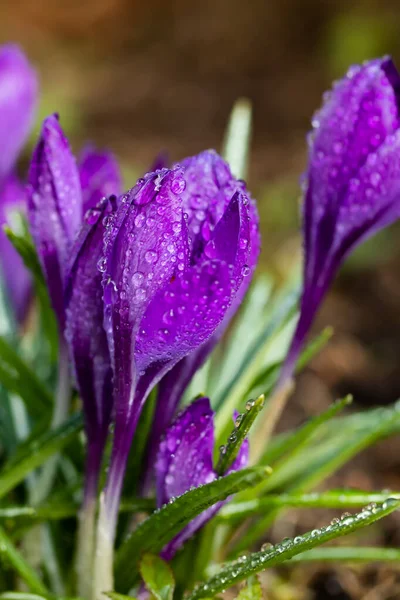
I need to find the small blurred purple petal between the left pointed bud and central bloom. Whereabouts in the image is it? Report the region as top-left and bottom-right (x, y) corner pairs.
(79, 146), (122, 213)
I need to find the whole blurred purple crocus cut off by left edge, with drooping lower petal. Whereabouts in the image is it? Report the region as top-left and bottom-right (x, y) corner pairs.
(0, 44), (38, 321)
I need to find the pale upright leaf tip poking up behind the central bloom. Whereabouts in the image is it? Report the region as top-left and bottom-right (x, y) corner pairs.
(222, 98), (251, 179)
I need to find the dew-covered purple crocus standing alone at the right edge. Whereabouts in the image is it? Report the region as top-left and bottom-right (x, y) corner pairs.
(280, 58), (400, 384)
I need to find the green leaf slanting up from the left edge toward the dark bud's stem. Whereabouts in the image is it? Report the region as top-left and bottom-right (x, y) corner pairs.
(0, 413), (83, 498)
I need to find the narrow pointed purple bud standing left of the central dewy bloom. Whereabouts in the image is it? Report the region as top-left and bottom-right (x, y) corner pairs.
(28, 116), (82, 329)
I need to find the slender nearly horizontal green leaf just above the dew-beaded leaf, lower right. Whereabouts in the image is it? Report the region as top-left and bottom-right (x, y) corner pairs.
(219, 490), (400, 521)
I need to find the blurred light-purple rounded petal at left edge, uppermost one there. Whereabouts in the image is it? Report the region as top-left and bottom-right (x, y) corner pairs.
(0, 44), (38, 180)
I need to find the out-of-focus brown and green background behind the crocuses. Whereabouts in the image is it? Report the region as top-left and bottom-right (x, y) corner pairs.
(0, 0), (400, 600)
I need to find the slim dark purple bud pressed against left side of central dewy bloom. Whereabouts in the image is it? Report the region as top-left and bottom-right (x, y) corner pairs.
(65, 199), (113, 497)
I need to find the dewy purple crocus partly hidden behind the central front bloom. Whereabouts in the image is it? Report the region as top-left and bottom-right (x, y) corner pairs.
(143, 151), (260, 492)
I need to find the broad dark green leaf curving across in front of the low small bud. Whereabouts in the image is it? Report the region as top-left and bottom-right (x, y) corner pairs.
(115, 467), (268, 591)
